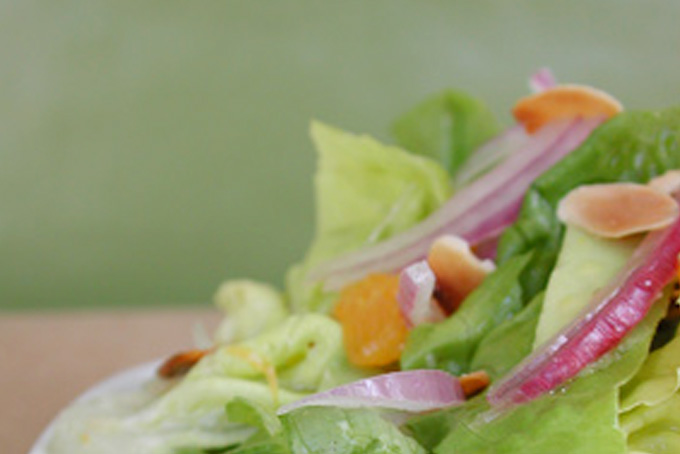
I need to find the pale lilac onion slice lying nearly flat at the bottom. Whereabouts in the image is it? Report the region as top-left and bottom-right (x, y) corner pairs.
(277, 370), (465, 415)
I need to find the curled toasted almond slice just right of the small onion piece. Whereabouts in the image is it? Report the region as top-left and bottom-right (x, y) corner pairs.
(427, 235), (495, 310)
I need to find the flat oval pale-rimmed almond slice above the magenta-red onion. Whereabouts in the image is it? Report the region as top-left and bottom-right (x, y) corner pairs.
(557, 183), (678, 238)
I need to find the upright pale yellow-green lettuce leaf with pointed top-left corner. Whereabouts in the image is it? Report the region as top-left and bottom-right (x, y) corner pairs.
(287, 122), (452, 312)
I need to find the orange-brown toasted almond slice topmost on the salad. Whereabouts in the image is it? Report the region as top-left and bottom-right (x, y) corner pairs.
(512, 85), (623, 133)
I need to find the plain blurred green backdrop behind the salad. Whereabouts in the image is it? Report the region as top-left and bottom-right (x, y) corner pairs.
(0, 0), (680, 309)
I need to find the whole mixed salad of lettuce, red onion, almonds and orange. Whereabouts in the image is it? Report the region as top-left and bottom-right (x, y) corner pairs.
(41, 70), (680, 454)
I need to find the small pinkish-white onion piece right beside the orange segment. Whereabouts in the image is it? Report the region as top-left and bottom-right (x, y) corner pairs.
(397, 260), (446, 327)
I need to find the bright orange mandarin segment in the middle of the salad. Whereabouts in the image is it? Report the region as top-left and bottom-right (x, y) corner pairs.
(334, 274), (408, 367)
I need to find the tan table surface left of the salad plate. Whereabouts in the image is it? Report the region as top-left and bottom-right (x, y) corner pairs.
(0, 307), (220, 454)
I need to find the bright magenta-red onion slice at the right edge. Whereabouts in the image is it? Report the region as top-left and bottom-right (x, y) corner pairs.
(487, 197), (680, 408)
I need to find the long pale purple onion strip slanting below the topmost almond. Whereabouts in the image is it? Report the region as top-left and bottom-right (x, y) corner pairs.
(308, 118), (602, 290)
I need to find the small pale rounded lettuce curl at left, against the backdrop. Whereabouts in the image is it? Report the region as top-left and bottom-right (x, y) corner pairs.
(214, 279), (288, 344)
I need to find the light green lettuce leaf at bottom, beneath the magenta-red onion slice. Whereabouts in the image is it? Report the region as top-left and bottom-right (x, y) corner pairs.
(408, 304), (663, 454)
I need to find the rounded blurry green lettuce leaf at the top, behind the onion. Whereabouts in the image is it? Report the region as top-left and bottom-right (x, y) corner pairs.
(392, 90), (500, 175)
